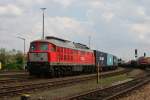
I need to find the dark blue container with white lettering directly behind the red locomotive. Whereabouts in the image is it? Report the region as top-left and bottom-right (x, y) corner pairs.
(94, 50), (107, 67)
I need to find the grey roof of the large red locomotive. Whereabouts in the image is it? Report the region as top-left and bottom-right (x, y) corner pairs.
(33, 36), (92, 52)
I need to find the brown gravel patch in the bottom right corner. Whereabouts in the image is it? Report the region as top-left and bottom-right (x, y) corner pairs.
(118, 83), (150, 100)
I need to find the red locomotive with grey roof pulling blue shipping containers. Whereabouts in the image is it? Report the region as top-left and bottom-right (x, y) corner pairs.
(27, 36), (118, 76)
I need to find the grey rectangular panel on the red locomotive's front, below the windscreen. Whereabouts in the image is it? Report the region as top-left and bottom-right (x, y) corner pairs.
(29, 53), (48, 62)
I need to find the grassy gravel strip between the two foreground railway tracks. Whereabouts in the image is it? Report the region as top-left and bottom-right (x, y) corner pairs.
(9, 74), (129, 100)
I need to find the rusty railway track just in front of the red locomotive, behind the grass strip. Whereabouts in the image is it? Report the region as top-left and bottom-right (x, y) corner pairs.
(0, 70), (126, 97)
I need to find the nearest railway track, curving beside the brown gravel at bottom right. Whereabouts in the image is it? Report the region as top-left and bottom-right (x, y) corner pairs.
(63, 70), (150, 100)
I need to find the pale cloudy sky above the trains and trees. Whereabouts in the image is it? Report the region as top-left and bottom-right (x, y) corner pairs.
(0, 0), (150, 60)
